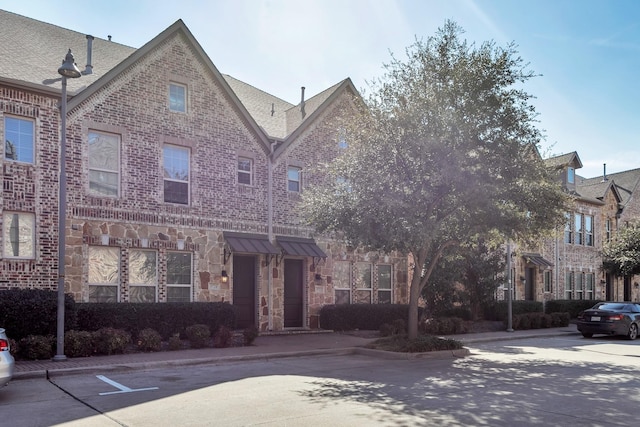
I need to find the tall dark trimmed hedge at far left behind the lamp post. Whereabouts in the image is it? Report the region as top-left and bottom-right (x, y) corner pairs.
(0, 289), (76, 341)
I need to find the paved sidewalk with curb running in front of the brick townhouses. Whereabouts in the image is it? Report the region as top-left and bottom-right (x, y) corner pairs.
(13, 325), (578, 380)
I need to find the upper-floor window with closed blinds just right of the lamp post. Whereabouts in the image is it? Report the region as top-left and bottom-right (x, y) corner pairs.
(88, 130), (120, 197)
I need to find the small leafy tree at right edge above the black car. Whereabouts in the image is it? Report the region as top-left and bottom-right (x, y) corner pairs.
(602, 223), (640, 277)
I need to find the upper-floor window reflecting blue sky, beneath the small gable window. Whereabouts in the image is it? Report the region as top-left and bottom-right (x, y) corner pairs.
(163, 144), (191, 205)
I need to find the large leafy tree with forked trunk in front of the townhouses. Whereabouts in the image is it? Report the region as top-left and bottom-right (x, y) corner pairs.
(302, 21), (566, 338)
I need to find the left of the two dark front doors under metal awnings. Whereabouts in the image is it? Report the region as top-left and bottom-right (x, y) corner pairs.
(233, 255), (256, 329)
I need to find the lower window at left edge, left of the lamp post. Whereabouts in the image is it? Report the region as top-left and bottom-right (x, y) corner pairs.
(2, 212), (36, 259)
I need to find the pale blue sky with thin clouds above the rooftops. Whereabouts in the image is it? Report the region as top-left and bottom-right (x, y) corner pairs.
(0, 0), (640, 177)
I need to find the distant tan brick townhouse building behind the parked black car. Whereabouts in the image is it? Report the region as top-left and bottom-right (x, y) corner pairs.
(512, 152), (640, 301)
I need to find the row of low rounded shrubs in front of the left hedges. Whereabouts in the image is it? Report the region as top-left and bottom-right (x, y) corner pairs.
(11, 324), (258, 360)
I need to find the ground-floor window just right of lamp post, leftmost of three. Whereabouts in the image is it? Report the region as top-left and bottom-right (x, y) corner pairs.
(88, 246), (120, 302)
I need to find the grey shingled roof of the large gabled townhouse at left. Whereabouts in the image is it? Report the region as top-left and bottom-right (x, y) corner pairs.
(0, 10), (356, 145)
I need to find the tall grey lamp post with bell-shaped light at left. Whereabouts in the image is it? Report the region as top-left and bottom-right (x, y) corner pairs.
(53, 49), (82, 361)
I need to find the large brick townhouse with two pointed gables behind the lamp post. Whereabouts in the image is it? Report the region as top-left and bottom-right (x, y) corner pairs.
(0, 11), (408, 331)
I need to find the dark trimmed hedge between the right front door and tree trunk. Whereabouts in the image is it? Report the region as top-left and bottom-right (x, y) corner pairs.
(320, 304), (422, 331)
